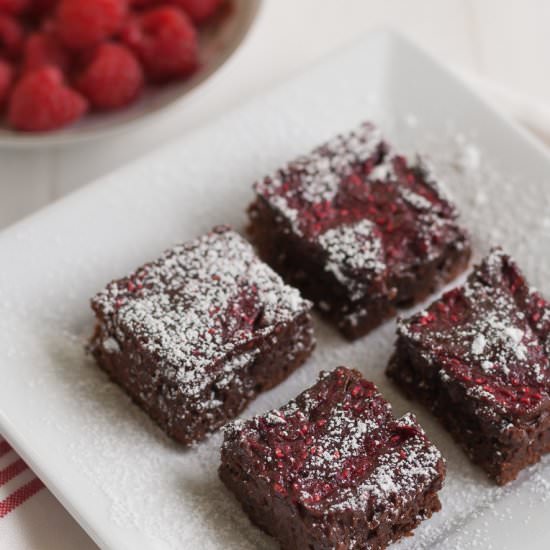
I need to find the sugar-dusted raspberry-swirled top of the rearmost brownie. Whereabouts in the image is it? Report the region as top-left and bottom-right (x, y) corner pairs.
(251, 119), (468, 306)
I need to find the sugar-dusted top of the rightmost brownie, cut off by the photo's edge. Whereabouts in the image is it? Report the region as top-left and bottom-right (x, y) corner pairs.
(399, 249), (550, 416)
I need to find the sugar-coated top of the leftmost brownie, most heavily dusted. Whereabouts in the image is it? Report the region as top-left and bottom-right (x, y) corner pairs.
(93, 228), (310, 406)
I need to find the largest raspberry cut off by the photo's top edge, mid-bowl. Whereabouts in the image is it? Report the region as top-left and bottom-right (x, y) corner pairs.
(56, 0), (127, 49)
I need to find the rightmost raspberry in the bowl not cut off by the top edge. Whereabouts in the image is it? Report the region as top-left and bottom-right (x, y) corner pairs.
(122, 7), (198, 81)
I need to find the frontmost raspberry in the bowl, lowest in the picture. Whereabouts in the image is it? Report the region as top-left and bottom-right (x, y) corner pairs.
(8, 67), (87, 132)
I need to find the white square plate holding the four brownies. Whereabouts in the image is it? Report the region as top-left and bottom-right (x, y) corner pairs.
(0, 32), (550, 550)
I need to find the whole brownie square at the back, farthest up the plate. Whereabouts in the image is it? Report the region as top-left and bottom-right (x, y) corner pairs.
(249, 123), (470, 339)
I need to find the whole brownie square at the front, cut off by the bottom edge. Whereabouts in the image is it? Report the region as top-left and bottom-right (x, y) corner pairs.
(219, 367), (445, 550)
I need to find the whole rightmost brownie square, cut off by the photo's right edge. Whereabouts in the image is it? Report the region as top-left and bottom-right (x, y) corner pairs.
(387, 249), (550, 485)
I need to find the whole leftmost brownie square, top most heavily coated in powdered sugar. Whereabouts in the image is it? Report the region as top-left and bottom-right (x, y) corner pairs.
(91, 227), (314, 445)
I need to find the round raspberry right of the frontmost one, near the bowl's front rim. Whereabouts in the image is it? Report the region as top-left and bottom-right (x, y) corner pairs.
(77, 43), (143, 109)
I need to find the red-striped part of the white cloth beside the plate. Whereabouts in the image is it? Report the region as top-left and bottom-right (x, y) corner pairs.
(0, 436), (44, 519)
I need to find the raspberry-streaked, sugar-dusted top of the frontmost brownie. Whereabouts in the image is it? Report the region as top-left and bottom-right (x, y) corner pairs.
(224, 367), (443, 522)
